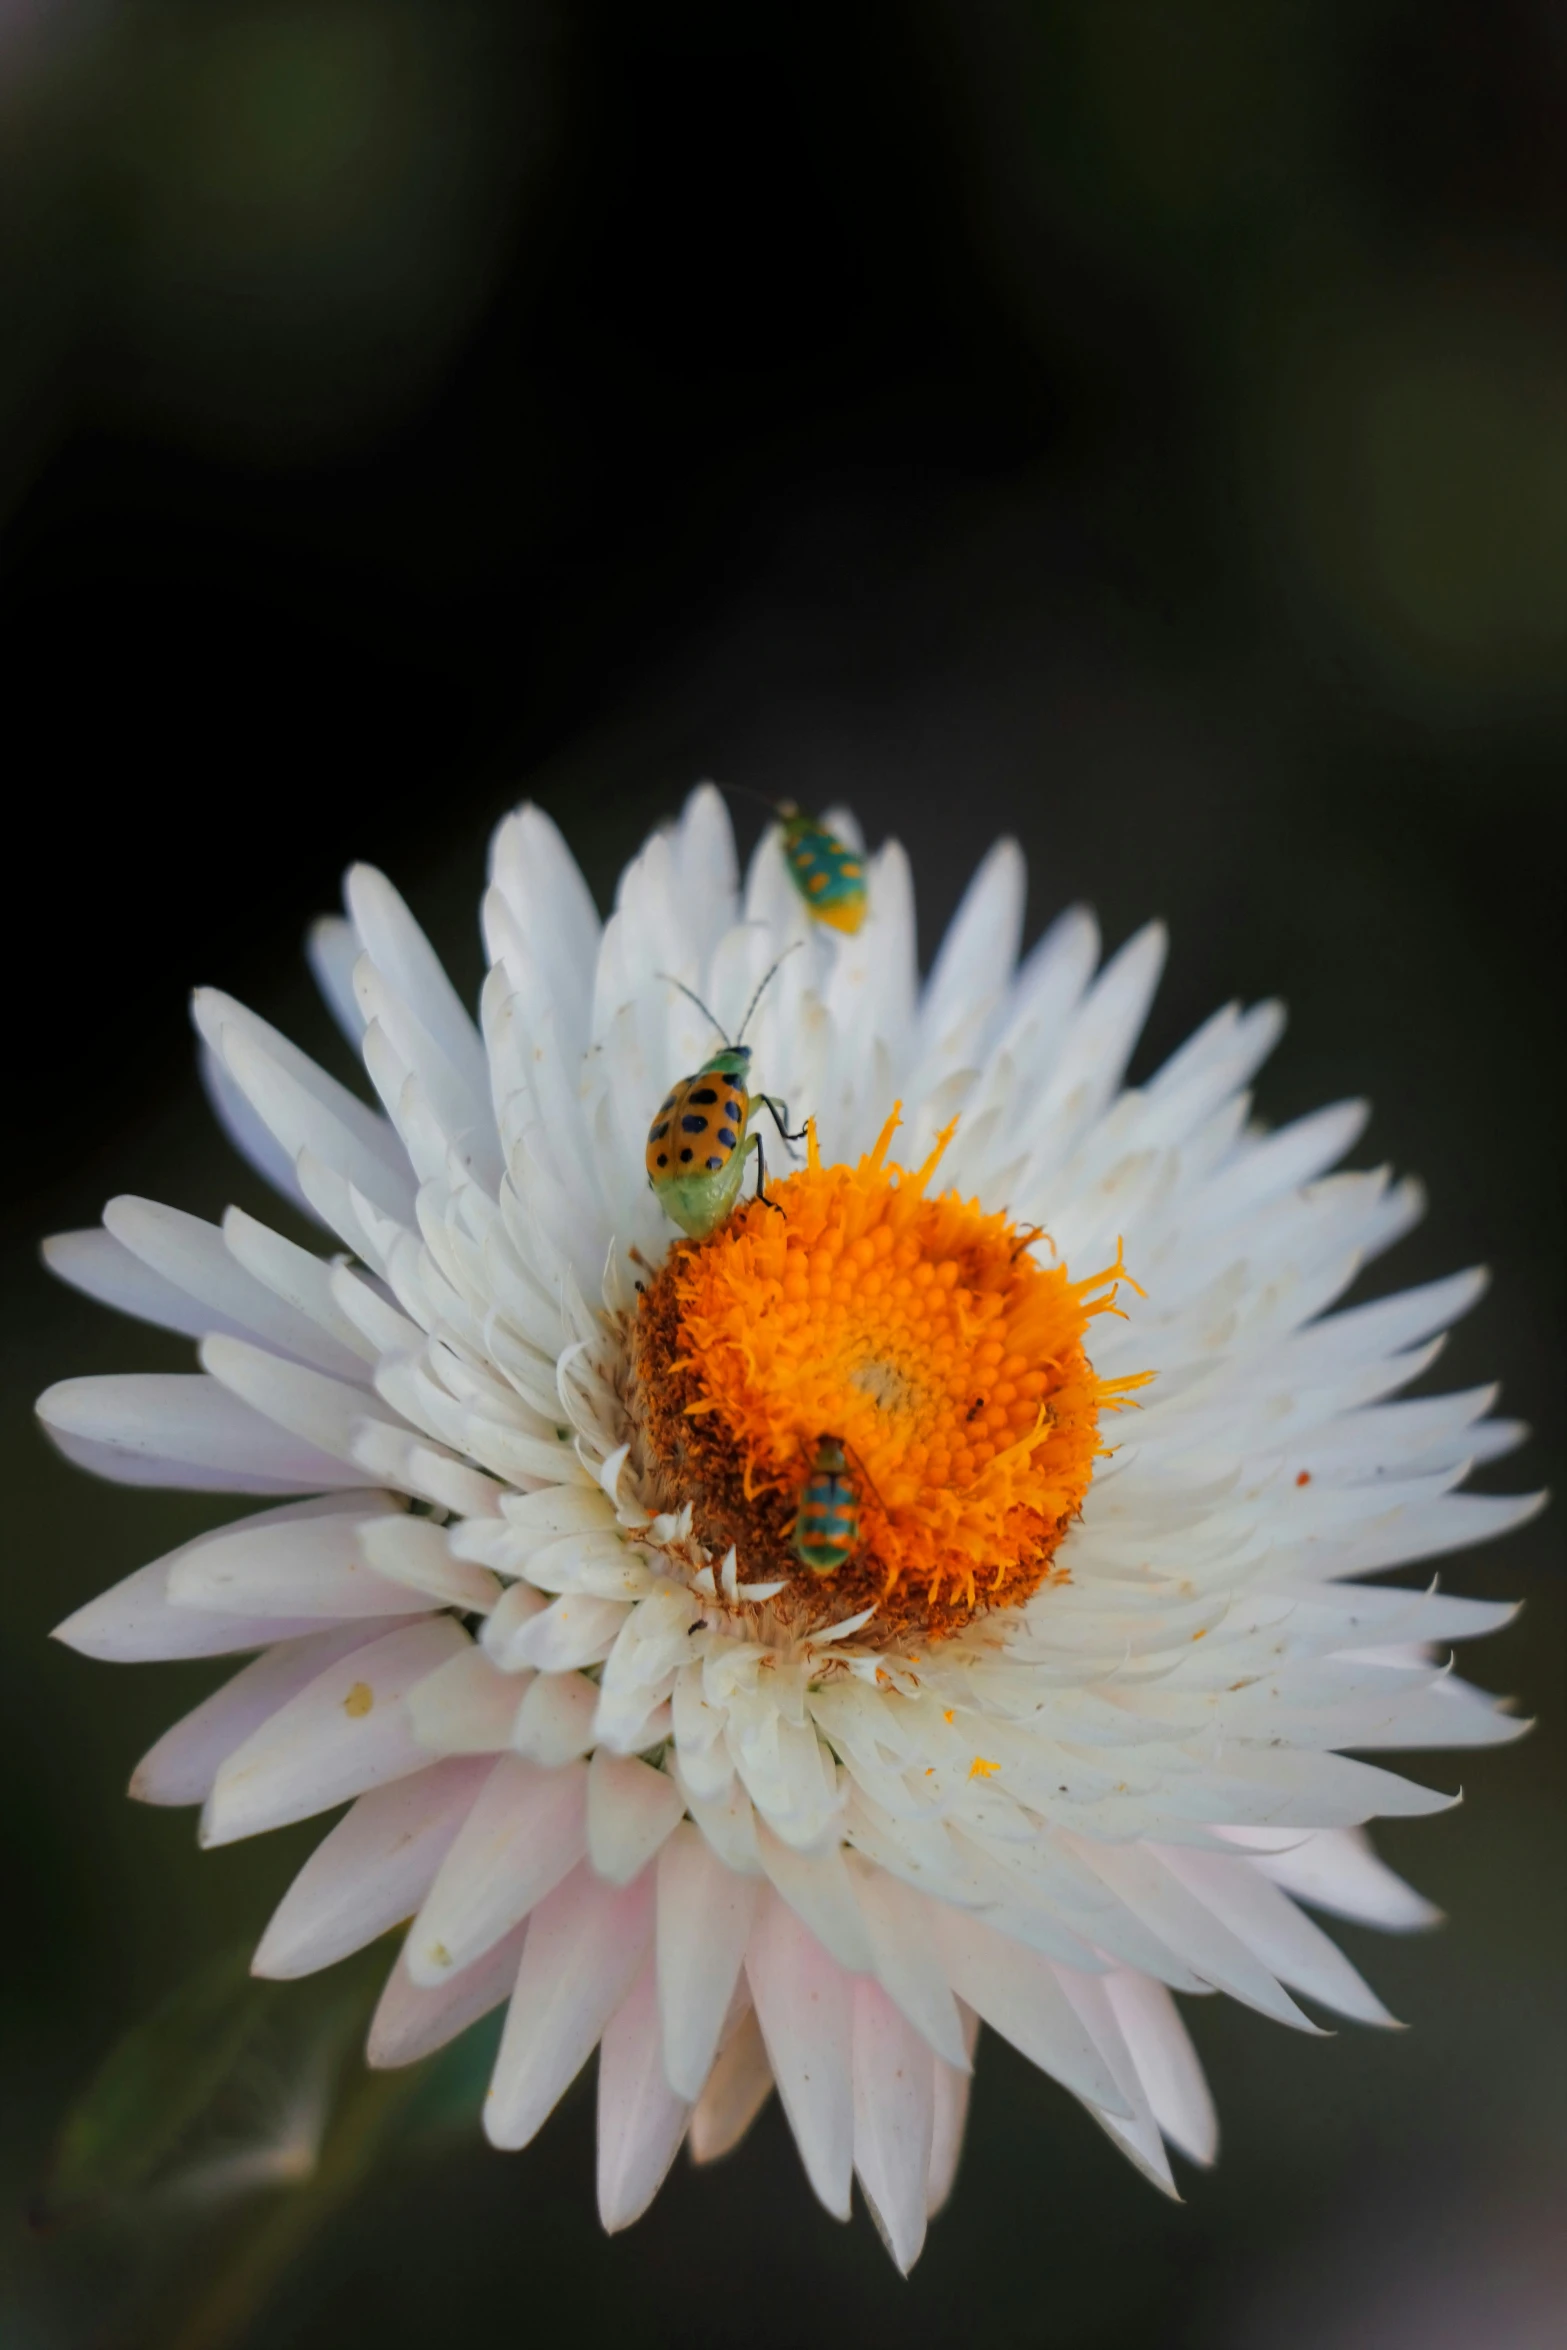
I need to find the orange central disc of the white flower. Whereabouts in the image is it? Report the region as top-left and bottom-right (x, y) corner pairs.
(637, 1112), (1142, 1638)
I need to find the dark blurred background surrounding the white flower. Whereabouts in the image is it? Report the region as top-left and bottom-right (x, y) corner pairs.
(0, 0), (1567, 2350)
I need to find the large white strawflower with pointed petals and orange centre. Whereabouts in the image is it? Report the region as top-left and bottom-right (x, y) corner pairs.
(40, 787), (1534, 2268)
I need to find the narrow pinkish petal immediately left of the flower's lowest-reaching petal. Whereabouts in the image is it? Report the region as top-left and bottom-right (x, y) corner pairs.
(745, 1892), (855, 2218)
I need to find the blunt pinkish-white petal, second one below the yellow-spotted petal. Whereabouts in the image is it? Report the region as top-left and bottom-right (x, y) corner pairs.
(406, 1755), (587, 1983)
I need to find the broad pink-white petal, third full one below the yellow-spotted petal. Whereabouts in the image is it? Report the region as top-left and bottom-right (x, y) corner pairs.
(484, 1868), (653, 2148)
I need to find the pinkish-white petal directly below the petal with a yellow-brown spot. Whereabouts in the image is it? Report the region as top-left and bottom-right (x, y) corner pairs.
(251, 1760), (486, 1979)
